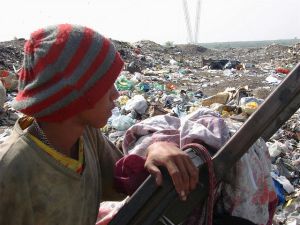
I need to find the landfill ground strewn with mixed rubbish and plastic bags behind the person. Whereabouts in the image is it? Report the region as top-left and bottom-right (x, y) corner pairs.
(0, 39), (300, 225)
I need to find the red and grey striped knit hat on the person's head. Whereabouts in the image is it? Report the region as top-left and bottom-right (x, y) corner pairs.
(13, 24), (124, 122)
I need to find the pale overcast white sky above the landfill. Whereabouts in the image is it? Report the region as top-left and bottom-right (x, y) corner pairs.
(0, 0), (300, 44)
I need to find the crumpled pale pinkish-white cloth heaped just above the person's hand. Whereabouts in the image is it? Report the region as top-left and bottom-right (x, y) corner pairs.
(123, 108), (229, 156)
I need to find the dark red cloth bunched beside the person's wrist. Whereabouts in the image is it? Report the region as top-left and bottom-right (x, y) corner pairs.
(115, 154), (149, 195)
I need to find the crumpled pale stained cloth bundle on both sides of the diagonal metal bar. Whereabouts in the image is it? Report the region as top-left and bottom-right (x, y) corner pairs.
(96, 108), (277, 224)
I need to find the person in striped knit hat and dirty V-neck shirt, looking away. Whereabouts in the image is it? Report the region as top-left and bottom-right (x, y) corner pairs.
(0, 24), (198, 225)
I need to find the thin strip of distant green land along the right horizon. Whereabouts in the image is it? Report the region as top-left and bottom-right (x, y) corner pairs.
(199, 38), (300, 49)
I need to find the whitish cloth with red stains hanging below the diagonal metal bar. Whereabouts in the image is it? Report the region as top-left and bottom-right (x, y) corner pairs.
(216, 120), (278, 225)
